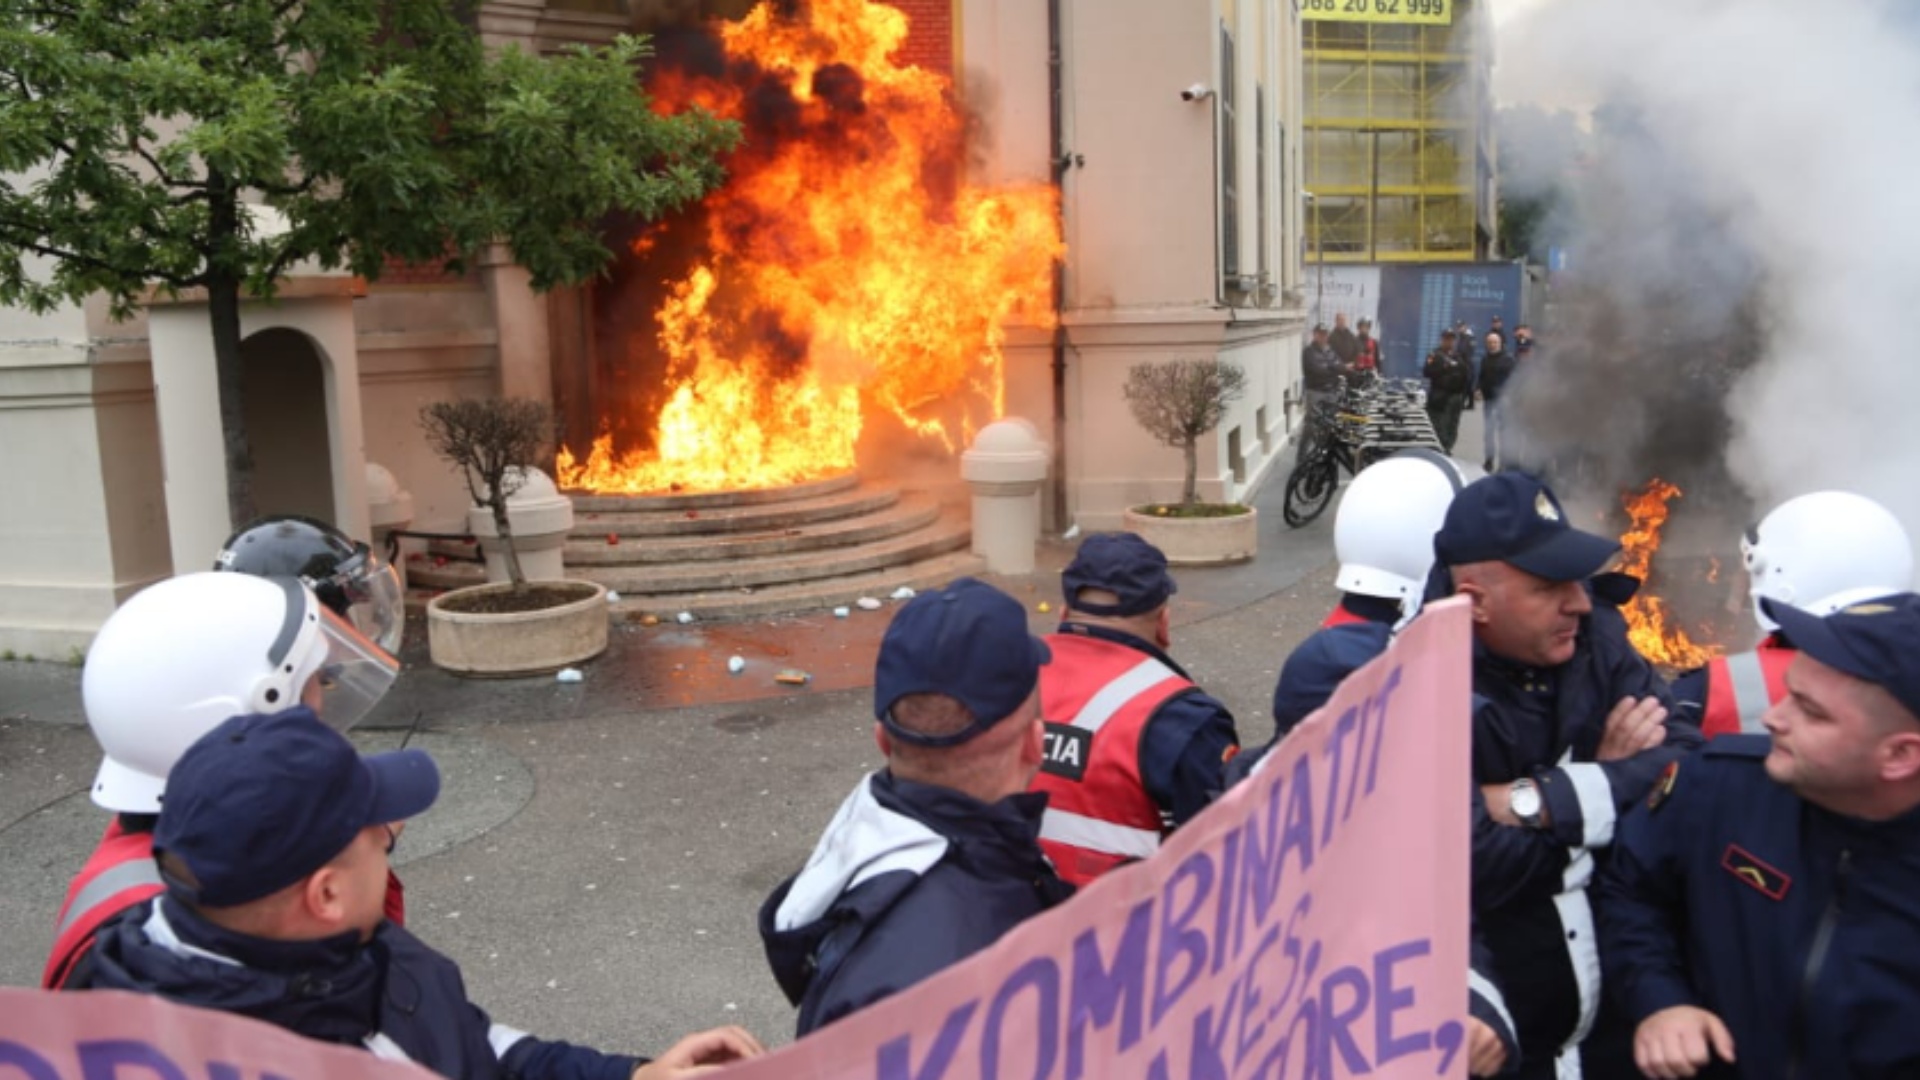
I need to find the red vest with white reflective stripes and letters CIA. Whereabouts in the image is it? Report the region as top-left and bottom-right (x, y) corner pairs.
(1031, 634), (1192, 886)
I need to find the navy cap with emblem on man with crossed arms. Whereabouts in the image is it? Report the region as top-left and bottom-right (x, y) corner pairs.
(1434, 473), (1620, 580)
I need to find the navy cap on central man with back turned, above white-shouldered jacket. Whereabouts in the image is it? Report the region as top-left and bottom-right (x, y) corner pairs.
(874, 578), (1052, 748)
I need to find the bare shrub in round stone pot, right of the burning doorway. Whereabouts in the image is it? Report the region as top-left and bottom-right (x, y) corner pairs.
(1125, 359), (1260, 563)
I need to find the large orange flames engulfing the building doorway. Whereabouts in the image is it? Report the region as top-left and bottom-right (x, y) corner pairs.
(557, 0), (1062, 492)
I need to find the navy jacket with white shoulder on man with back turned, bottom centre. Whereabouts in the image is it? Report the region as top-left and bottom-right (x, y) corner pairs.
(760, 773), (1073, 1036)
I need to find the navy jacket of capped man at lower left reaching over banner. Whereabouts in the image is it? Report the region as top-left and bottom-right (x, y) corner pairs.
(67, 894), (645, 1080)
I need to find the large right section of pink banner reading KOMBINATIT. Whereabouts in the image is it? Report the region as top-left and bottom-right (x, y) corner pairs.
(726, 601), (1471, 1080)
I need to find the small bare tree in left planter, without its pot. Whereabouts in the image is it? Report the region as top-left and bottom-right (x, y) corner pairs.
(420, 398), (553, 592)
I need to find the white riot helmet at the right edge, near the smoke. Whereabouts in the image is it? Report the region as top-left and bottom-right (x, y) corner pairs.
(1740, 492), (1914, 632)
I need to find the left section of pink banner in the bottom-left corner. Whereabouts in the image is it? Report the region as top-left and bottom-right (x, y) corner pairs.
(0, 990), (434, 1080)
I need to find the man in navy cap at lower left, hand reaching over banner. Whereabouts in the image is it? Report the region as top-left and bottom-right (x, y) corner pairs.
(71, 707), (760, 1080)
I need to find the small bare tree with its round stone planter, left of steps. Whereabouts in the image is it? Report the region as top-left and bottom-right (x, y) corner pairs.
(420, 398), (607, 675)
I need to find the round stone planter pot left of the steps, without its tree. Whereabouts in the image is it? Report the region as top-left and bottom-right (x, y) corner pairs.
(426, 580), (609, 676)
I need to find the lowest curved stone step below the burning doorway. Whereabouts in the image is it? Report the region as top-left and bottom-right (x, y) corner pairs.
(568, 517), (972, 596)
